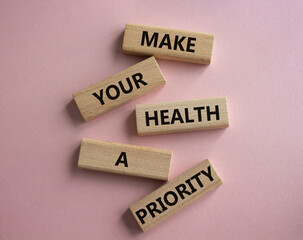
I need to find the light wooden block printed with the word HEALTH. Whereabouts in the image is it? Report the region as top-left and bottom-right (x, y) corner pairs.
(136, 97), (229, 136)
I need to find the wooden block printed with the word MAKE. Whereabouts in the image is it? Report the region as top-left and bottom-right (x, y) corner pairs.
(122, 23), (214, 64)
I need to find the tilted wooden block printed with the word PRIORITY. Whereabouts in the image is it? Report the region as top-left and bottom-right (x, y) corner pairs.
(130, 160), (222, 232)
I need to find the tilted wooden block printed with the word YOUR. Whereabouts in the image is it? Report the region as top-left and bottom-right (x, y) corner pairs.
(73, 57), (165, 121)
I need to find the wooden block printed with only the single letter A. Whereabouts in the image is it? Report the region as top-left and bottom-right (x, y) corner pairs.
(78, 138), (172, 180)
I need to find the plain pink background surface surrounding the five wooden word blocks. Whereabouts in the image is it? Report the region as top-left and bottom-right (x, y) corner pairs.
(0, 0), (303, 240)
